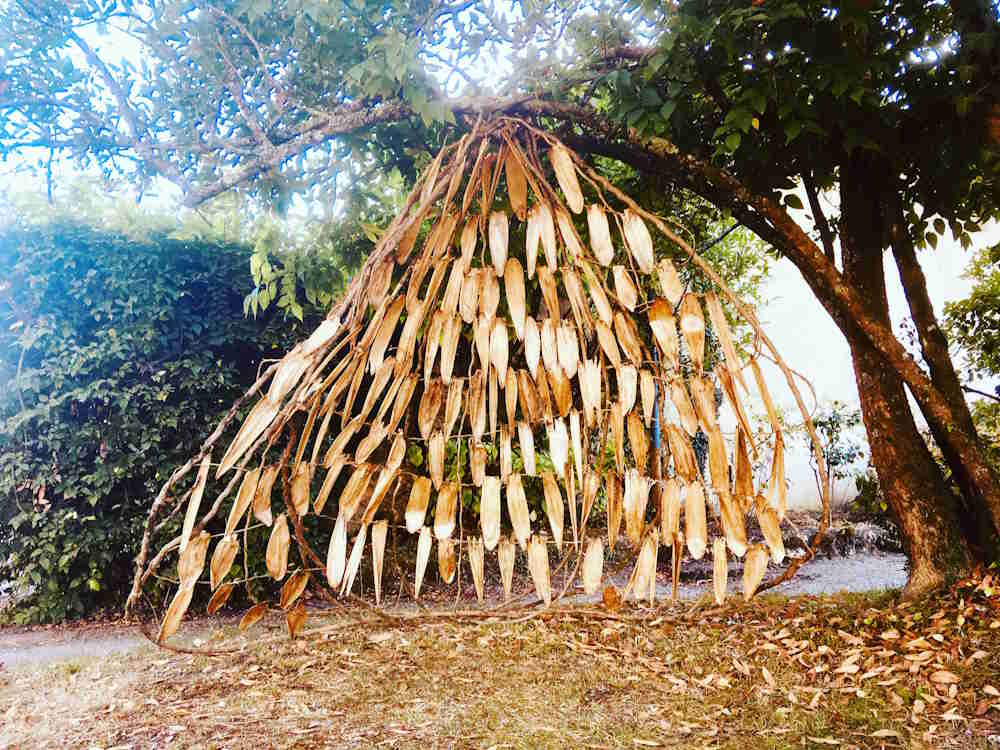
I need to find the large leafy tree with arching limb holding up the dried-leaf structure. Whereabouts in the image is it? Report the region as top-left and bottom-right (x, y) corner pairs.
(0, 0), (1000, 593)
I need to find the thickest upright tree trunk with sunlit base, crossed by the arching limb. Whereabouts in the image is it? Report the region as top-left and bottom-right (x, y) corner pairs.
(840, 156), (971, 596)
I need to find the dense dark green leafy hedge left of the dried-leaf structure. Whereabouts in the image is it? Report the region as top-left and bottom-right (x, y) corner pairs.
(0, 222), (318, 623)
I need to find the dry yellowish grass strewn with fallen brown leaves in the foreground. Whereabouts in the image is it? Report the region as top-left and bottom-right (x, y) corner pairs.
(0, 586), (1000, 748)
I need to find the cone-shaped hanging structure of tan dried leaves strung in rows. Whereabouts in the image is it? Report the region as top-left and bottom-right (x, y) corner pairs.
(134, 118), (825, 640)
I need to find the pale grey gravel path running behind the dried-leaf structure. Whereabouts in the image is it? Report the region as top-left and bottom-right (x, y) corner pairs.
(0, 553), (906, 668)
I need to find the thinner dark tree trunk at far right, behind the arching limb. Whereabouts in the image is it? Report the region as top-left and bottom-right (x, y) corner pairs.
(890, 198), (1000, 558)
